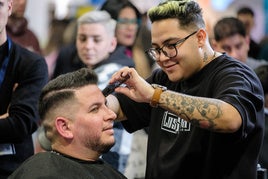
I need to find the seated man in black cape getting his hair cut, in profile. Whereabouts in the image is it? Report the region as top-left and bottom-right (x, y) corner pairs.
(9, 68), (126, 179)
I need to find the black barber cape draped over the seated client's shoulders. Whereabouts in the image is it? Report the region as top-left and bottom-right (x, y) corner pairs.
(9, 152), (126, 179)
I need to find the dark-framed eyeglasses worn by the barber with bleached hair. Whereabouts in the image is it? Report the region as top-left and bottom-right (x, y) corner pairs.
(145, 30), (198, 61)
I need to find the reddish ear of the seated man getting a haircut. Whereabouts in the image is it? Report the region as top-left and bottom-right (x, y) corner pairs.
(55, 117), (73, 139)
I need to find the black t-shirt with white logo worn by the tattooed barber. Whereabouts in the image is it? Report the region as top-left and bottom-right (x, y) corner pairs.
(117, 54), (264, 179)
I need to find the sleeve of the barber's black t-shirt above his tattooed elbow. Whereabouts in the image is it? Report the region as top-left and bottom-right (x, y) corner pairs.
(215, 64), (264, 137)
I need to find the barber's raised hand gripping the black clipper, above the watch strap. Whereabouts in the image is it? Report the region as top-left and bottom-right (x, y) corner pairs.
(110, 67), (154, 103)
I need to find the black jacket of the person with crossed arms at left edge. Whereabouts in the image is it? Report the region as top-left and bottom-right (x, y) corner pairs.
(0, 38), (48, 178)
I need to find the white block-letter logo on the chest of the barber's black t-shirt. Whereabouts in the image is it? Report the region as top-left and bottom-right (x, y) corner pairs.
(161, 111), (191, 134)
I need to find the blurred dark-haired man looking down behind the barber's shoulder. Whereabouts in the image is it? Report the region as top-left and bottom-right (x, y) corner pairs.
(212, 17), (268, 69)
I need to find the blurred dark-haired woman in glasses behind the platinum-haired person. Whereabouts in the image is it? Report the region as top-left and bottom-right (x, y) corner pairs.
(101, 0), (151, 78)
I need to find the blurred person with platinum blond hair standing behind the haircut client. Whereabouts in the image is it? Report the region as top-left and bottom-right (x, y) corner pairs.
(50, 10), (135, 173)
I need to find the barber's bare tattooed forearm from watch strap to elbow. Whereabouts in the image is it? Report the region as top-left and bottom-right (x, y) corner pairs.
(159, 91), (242, 133)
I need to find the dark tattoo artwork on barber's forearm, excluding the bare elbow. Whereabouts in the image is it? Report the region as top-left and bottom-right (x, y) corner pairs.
(159, 91), (223, 130)
